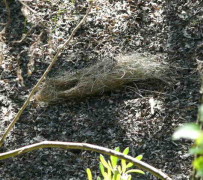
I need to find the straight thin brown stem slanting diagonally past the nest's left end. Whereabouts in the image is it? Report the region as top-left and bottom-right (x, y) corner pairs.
(0, 1), (93, 147)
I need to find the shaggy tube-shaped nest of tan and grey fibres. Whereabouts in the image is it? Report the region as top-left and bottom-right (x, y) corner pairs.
(36, 54), (168, 102)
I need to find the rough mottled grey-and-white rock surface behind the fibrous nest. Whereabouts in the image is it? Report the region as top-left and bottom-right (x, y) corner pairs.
(0, 0), (203, 180)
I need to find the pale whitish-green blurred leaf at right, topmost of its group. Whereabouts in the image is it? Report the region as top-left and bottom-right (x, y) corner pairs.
(173, 123), (202, 140)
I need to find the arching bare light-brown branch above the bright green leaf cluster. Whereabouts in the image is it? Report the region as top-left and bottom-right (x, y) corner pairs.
(0, 141), (172, 180)
